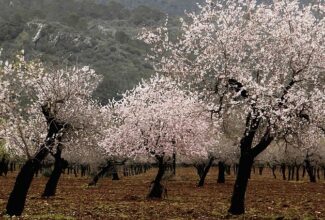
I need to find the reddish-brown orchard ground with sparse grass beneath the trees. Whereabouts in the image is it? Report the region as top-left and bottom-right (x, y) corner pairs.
(0, 168), (325, 220)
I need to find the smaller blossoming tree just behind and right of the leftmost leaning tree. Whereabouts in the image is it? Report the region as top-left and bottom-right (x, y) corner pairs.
(42, 98), (103, 197)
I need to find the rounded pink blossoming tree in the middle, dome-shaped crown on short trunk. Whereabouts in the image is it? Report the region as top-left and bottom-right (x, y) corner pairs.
(101, 75), (217, 198)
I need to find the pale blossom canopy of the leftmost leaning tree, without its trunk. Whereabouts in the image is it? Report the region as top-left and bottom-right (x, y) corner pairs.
(0, 52), (102, 160)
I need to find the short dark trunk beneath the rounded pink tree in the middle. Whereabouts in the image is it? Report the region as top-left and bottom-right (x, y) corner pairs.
(148, 156), (166, 199)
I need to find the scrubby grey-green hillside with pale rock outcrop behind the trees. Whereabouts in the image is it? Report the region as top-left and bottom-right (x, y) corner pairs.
(0, 0), (171, 103)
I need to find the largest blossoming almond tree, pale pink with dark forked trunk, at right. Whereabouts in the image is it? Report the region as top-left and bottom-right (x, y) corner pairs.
(140, 0), (325, 214)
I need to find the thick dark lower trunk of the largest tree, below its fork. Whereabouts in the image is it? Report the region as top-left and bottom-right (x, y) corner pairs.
(228, 152), (254, 215)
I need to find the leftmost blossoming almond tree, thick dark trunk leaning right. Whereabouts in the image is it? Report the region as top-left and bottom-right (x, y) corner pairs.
(1, 55), (101, 215)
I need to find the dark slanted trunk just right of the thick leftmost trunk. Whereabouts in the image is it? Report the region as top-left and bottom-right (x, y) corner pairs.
(42, 144), (68, 197)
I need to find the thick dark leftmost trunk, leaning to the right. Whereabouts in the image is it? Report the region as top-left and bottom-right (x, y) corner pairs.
(6, 146), (49, 216)
